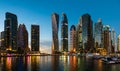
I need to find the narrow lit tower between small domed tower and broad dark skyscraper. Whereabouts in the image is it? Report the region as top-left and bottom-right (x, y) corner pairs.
(76, 20), (83, 52)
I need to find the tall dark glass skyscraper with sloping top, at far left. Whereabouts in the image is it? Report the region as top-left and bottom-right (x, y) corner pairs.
(4, 12), (18, 50)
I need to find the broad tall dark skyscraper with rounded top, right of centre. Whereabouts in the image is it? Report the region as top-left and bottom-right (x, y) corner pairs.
(80, 14), (93, 51)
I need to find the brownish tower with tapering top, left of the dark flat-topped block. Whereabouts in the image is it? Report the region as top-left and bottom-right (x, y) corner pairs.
(17, 24), (28, 51)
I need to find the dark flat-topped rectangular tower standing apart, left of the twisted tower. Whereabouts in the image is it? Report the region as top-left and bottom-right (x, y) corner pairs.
(31, 25), (40, 51)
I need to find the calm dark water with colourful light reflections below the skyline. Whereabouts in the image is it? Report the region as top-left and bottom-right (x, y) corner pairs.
(0, 56), (120, 71)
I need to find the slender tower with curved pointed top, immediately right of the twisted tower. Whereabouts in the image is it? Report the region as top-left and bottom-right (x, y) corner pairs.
(61, 13), (68, 52)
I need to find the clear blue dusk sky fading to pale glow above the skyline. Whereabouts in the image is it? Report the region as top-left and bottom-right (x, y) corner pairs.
(0, 0), (120, 53)
